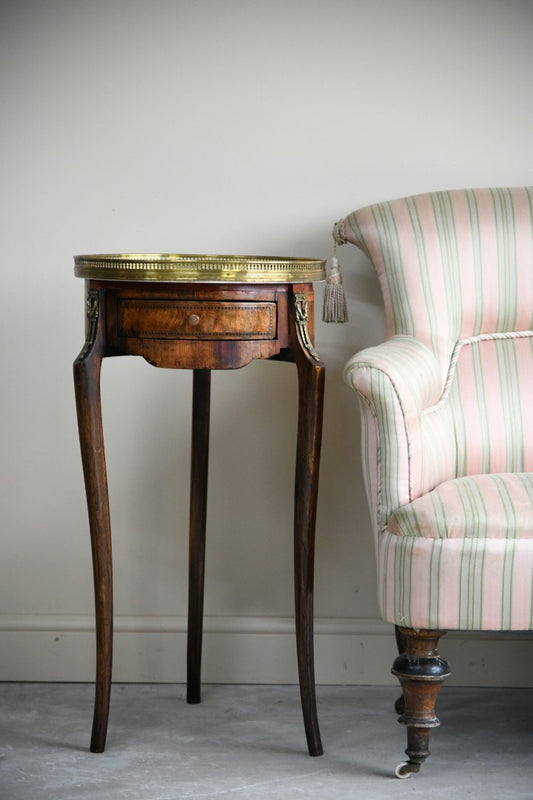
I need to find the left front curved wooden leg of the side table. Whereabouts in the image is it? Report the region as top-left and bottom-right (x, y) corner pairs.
(74, 291), (113, 753)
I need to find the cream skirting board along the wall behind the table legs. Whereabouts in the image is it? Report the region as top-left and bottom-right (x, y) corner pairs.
(0, 615), (533, 686)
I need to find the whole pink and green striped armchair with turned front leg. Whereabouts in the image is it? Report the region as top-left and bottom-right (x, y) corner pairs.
(334, 187), (533, 777)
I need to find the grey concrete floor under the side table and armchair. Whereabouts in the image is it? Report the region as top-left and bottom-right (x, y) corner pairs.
(0, 683), (533, 800)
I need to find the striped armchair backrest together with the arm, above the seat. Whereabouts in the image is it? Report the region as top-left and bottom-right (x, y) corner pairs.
(344, 187), (533, 529)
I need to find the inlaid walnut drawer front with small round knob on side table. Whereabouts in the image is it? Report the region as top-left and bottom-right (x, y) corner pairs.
(118, 299), (276, 339)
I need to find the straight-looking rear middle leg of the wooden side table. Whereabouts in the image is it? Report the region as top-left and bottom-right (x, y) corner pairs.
(187, 369), (211, 703)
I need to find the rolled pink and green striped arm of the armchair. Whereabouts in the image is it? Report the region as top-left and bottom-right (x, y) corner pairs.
(344, 335), (456, 531)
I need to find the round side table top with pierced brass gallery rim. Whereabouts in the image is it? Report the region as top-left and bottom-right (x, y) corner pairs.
(74, 253), (326, 283)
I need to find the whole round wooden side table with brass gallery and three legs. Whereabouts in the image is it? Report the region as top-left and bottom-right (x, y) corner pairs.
(74, 254), (325, 756)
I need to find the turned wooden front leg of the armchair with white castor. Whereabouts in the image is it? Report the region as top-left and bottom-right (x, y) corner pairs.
(392, 628), (450, 778)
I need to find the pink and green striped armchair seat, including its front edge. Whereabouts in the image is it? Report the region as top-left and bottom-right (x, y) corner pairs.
(378, 473), (533, 631)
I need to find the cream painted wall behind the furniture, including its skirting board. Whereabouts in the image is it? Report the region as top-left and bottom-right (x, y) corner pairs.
(0, 0), (533, 683)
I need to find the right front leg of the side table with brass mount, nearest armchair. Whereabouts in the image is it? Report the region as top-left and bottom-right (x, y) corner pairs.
(292, 294), (325, 756)
